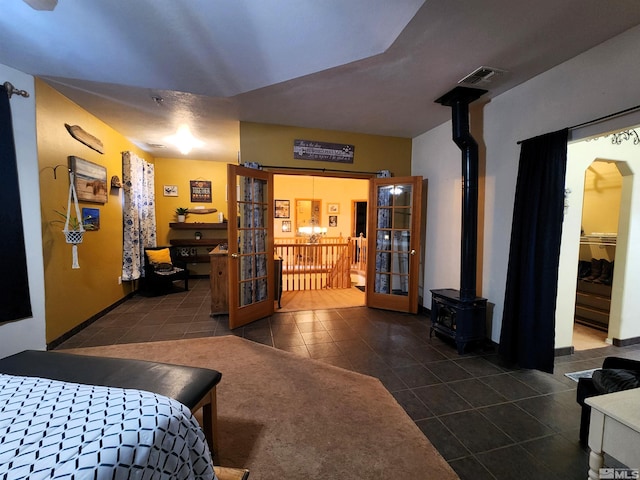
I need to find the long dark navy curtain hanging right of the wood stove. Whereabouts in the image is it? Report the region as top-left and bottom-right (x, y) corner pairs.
(499, 129), (569, 372)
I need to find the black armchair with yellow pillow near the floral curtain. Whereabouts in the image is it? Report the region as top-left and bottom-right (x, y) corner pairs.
(142, 247), (189, 295)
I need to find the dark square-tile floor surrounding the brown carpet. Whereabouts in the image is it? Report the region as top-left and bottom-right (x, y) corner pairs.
(58, 280), (640, 480)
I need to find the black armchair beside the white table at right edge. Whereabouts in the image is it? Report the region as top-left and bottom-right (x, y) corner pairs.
(576, 357), (640, 445)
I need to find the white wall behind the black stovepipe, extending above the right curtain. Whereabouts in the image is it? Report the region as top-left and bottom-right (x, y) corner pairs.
(412, 23), (640, 348)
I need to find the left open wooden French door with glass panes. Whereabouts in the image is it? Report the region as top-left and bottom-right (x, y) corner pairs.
(227, 164), (274, 329)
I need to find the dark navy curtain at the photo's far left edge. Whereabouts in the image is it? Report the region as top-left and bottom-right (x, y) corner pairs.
(0, 86), (31, 322)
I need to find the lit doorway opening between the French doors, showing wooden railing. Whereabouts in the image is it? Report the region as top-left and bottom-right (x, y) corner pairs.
(273, 172), (369, 312)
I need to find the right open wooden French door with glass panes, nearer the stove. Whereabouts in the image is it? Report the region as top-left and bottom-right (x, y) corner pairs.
(366, 177), (422, 313)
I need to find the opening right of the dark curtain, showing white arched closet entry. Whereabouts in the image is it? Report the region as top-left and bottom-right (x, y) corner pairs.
(555, 127), (640, 351)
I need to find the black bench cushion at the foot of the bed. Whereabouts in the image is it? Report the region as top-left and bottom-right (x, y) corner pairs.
(0, 350), (222, 410)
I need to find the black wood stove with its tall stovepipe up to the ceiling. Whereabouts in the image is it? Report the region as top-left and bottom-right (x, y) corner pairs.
(429, 87), (487, 354)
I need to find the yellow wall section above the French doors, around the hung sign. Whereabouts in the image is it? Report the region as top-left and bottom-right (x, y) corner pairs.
(240, 122), (411, 177)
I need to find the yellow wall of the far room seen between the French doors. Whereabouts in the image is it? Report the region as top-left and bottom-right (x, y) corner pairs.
(273, 175), (369, 239)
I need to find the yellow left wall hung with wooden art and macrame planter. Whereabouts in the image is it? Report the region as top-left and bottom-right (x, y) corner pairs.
(33, 79), (153, 343)
